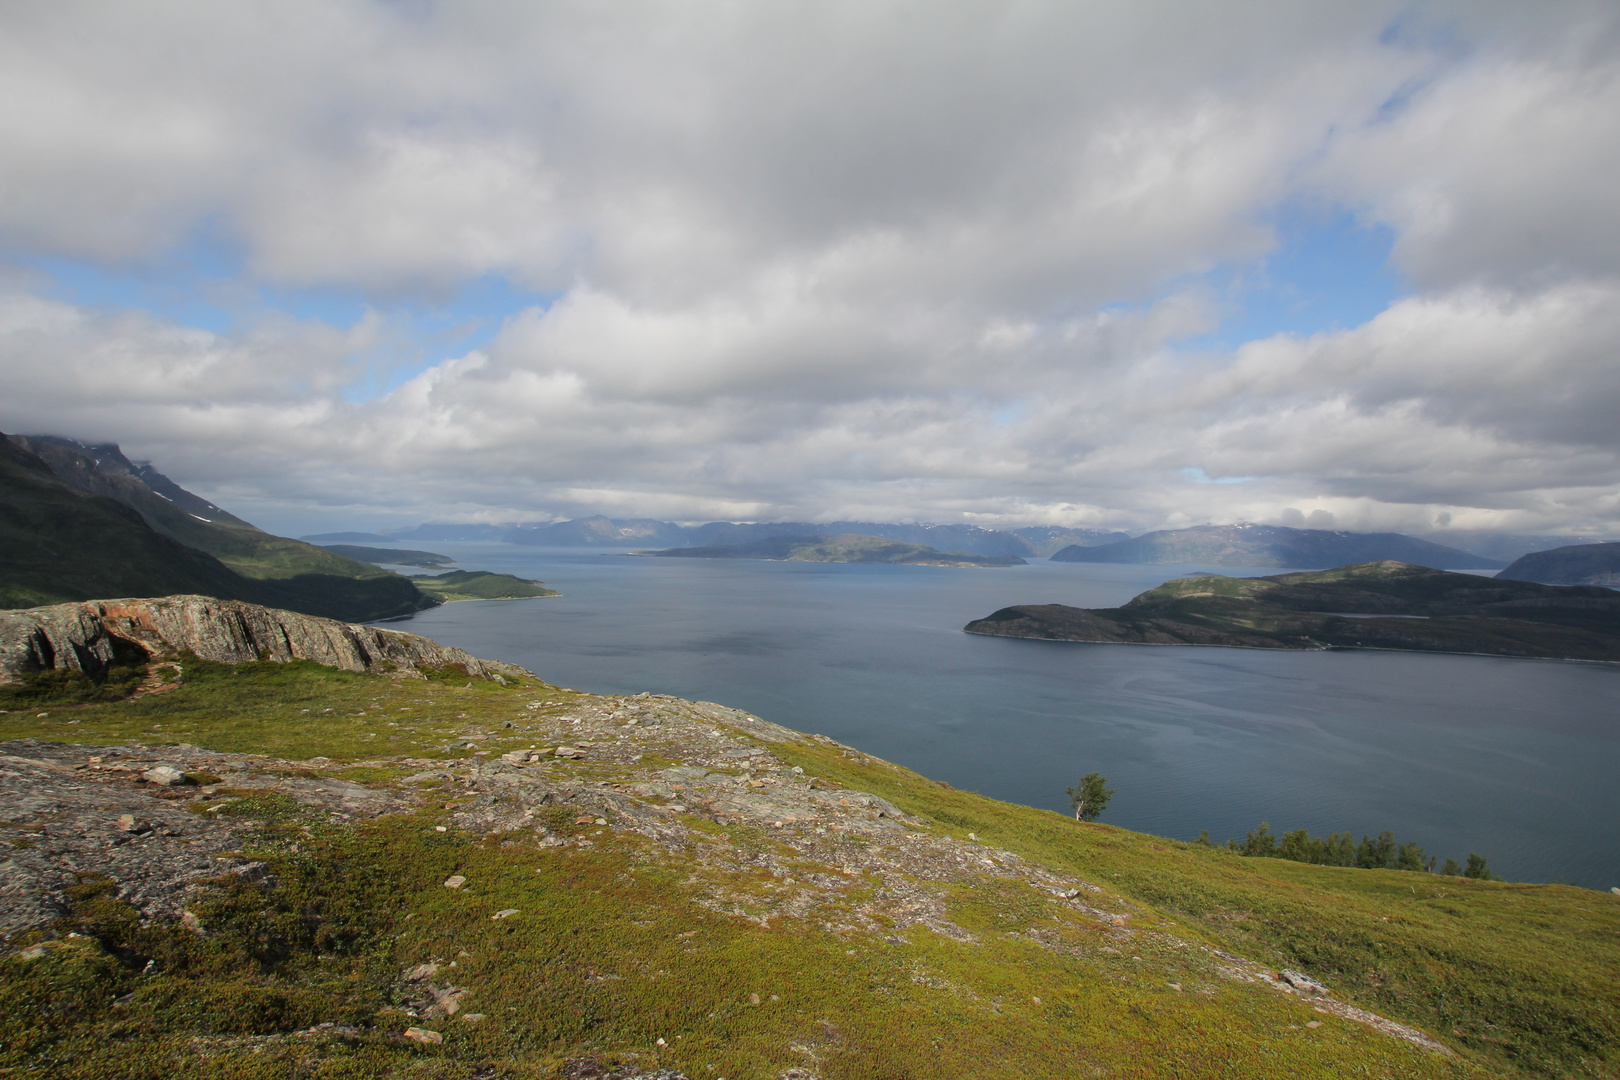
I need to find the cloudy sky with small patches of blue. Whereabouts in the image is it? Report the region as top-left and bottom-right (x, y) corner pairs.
(0, 0), (1620, 539)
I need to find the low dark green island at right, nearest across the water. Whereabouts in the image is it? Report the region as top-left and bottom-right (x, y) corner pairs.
(964, 562), (1620, 661)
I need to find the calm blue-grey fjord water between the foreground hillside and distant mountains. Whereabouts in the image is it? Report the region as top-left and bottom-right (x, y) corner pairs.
(392, 544), (1620, 889)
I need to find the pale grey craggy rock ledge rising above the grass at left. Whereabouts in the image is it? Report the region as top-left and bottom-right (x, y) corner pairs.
(0, 596), (528, 682)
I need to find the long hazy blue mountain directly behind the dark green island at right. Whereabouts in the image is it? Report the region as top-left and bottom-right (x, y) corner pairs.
(1051, 525), (1502, 570)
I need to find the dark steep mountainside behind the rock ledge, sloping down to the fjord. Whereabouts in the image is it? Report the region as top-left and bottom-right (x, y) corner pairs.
(0, 436), (434, 622)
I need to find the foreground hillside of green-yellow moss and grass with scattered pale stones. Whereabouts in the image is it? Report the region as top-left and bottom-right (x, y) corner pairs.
(0, 662), (1620, 1080)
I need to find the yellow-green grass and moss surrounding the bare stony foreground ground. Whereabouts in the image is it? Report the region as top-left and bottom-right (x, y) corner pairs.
(0, 664), (1620, 1080)
